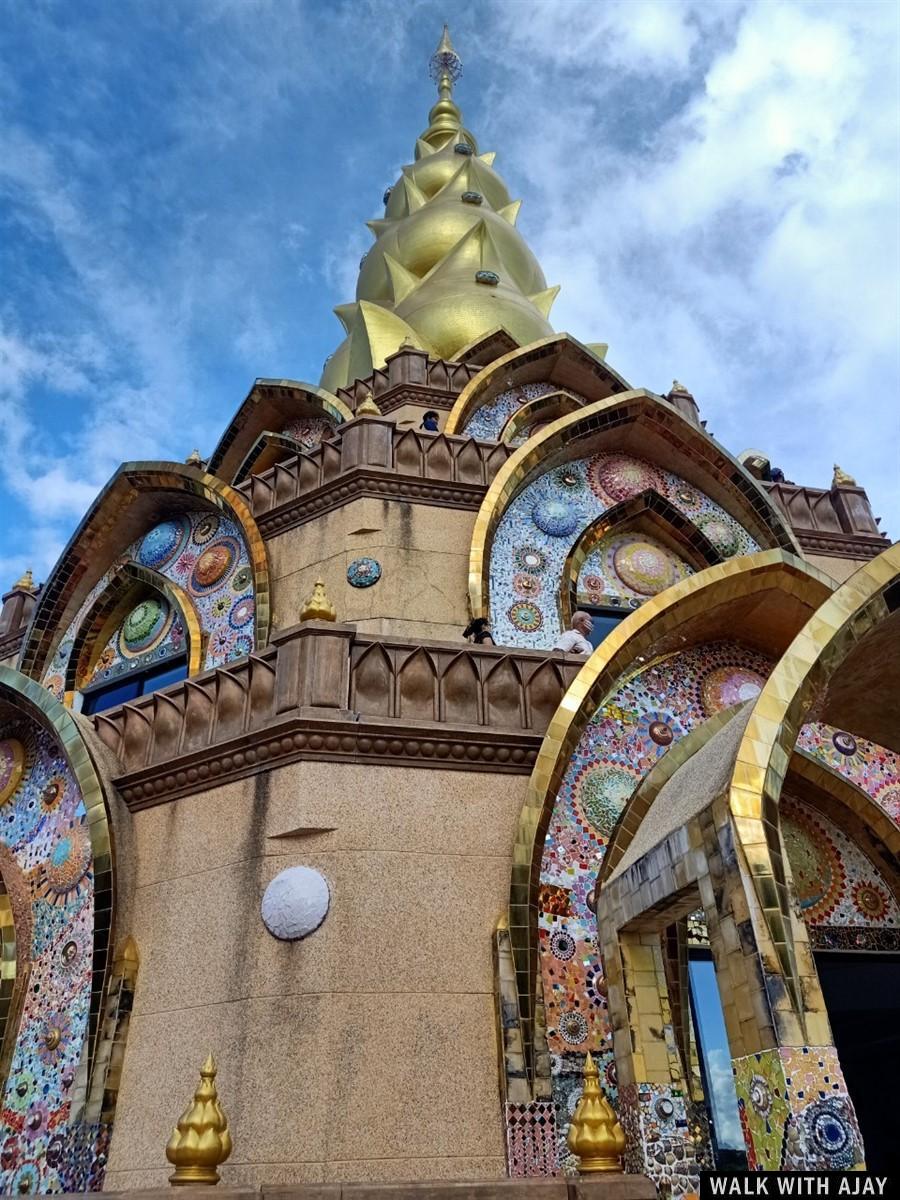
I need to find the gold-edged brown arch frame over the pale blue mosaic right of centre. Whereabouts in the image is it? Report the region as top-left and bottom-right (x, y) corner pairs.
(469, 390), (799, 638)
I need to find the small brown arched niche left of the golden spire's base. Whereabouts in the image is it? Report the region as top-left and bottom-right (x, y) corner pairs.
(206, 379), (353, 484)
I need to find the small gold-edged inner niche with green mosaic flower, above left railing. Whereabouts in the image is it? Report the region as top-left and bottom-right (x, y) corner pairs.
(65, 562), (209, 712)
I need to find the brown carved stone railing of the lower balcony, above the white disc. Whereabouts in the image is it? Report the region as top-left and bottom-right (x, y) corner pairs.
(92, 622), (583, 808)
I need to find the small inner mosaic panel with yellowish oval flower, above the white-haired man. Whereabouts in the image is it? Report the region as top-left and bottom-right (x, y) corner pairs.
(576, 533), (694, 605)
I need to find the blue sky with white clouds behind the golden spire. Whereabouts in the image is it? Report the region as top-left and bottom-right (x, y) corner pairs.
(0, 0), (900, 586)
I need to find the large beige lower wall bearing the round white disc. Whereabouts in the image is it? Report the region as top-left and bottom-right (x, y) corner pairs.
(106, 762), (527, 1190)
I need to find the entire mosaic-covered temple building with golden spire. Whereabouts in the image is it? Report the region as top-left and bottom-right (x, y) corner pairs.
(0, 23), (900, 1196)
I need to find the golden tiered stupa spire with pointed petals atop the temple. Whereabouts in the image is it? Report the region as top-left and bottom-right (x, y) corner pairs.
(322, 26), (558, 391)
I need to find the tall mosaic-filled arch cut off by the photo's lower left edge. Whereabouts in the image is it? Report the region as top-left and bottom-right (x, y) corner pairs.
(0, 666), (118, 1194)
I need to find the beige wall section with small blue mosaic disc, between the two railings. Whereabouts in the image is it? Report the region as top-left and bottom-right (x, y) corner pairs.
(268, 498), (475, 641)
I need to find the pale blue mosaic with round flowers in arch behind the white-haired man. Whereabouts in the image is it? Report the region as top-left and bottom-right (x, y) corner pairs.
(489, 453), (760, 649)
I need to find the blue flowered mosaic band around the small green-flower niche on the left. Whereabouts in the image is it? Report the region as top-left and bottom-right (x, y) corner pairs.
(43, 509), (256, 700)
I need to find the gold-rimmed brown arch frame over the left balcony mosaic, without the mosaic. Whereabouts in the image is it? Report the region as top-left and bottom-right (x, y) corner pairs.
(18, 462), (270, 678)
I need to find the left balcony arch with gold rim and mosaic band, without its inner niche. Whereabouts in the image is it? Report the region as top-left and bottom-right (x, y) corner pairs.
(19, 463), (270, 697)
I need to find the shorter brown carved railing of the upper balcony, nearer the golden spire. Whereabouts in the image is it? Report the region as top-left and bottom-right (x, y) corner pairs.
(232, 418), (511, 536)
